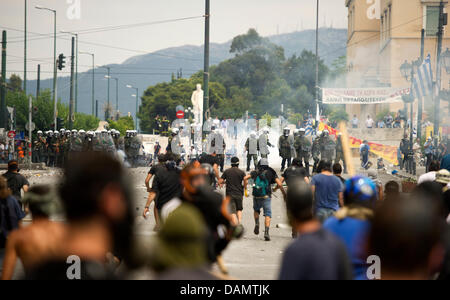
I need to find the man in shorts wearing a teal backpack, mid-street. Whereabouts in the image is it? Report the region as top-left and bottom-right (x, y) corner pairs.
(250, 158), (286, 241)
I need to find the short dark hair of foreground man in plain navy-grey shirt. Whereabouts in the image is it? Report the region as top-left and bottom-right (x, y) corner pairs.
(286, 179), (313, 222)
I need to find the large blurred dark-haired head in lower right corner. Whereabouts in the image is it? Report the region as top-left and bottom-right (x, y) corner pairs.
(367, 197), (445, 275)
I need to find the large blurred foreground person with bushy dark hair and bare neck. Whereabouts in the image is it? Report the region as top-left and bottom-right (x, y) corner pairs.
(27, 152), (134, 280)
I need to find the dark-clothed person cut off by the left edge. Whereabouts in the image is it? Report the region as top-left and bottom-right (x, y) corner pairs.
(0, 177), (25, 273)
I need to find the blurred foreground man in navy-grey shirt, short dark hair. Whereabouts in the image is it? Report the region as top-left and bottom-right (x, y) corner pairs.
(279, 180), (351, 280)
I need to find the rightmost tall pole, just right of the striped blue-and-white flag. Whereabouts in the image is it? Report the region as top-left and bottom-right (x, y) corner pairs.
(433, 0), (447, 138)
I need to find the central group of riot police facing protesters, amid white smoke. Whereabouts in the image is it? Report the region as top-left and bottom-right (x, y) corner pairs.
(167, 117), (347, 175)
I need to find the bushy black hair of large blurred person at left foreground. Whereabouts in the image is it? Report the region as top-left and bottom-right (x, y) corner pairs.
(59, 152), (131, 221)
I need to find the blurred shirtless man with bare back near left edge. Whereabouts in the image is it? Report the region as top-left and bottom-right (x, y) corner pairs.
(1, 186), (65, 280)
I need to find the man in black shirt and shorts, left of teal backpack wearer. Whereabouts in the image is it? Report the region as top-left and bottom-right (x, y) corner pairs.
(219, 157), (251, 225)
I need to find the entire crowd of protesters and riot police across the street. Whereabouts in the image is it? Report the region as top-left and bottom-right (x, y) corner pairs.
(0, 113), (450, 280)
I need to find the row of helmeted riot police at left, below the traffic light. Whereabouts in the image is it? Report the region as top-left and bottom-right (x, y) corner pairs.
(32, 129), (142, 168)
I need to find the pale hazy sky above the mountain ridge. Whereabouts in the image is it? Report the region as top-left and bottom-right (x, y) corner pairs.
(0, 0), (347, 79)
